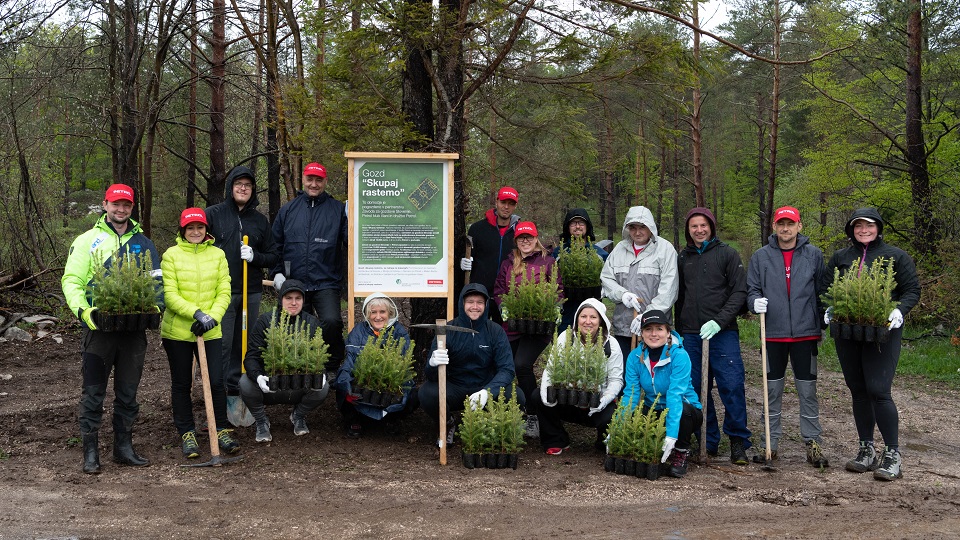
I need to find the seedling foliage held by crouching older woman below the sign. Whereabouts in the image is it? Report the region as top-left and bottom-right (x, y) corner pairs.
(353, 327), (416, 394)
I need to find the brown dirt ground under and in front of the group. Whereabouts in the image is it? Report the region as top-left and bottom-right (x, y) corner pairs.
(0, 331), (960, 540)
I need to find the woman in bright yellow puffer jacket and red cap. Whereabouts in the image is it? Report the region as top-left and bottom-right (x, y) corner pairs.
(160, 208), (240, 458)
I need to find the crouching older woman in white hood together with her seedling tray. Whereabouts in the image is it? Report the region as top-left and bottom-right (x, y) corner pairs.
(333, 293), (418, 439)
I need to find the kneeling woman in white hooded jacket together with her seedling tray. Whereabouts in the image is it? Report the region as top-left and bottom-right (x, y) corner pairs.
(539, 298), (623, 456)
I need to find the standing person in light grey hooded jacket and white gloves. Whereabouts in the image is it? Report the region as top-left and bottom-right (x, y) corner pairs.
(600, 206), (679, 362)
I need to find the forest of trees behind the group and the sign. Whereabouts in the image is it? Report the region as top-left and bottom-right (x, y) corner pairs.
(0, 0), (960, 354)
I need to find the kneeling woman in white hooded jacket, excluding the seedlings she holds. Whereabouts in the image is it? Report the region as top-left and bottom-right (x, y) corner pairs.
(539, 298), (623, 456)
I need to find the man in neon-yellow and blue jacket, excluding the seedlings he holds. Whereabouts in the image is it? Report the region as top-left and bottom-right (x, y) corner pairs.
(60, 184), (163, 474)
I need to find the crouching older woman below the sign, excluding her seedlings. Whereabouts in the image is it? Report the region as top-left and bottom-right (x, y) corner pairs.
(333, 293), (417, 439)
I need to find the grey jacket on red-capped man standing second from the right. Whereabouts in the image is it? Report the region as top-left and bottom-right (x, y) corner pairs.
(747, 234), (826, 338)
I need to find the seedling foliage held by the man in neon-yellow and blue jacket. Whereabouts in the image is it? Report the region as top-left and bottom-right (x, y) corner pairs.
(87, 250), (157, 314)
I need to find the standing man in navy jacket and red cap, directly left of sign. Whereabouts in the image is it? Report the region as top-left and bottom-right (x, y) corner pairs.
(273, 163), (347, 380)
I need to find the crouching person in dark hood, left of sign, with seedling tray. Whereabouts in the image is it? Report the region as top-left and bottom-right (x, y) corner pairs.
(240, 279), (330, 442)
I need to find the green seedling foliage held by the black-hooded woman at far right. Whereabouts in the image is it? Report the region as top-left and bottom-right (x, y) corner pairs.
(823, 257), (897, 326)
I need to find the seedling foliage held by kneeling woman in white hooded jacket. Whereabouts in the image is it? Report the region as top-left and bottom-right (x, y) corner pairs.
(546, 328), (607, 392)
